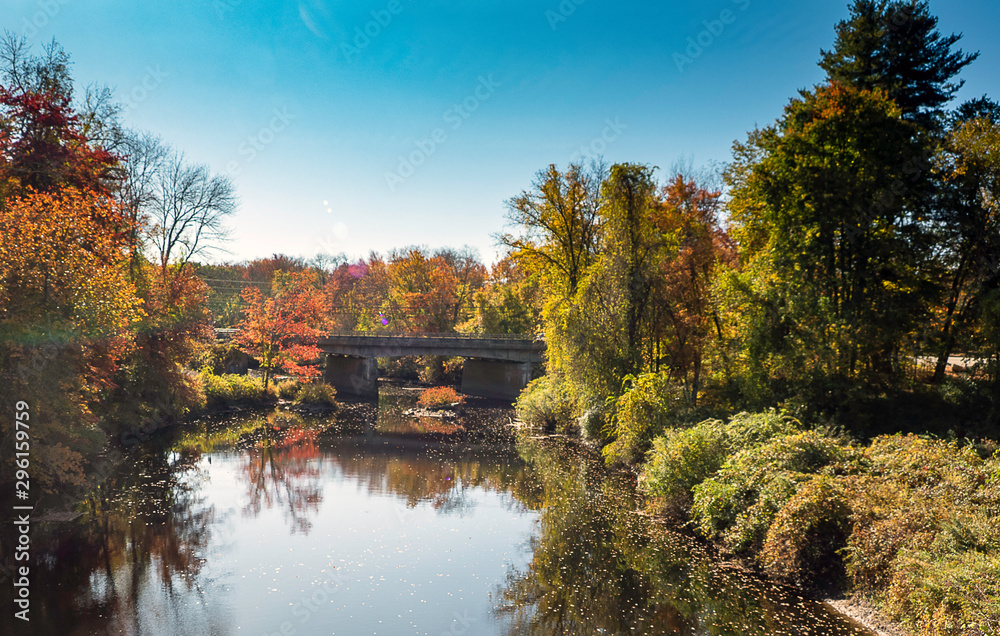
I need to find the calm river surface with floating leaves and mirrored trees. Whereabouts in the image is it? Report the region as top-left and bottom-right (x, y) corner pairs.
(0, 386), (869, 636)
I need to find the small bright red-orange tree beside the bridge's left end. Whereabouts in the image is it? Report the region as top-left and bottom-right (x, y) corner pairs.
(234, 272), (321, 389)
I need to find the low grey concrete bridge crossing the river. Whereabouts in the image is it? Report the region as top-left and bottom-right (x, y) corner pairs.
(316, 333), (545, 400)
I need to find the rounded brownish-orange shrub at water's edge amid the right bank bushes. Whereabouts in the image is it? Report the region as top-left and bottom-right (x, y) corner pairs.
(761, 475), (851, 586)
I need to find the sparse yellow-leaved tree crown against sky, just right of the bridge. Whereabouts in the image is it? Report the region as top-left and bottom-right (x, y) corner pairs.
(497, 164), (604, 298)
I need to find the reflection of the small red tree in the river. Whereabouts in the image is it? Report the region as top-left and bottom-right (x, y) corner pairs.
(242, 416), (323, 534)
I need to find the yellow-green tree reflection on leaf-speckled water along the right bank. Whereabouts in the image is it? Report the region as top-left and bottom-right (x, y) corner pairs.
(495, 439), (868, 636)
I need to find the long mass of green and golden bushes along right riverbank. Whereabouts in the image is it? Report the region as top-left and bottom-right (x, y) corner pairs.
(639, 411), (1000, 636)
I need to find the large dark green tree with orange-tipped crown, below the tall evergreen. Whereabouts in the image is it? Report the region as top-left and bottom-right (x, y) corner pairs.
(725, 84), (930, 390)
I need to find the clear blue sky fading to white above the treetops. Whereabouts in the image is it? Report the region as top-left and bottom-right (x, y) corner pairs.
(7, 0), (1000, 262)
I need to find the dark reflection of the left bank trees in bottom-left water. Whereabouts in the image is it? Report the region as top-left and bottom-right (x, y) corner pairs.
(0, 451), (227, 634)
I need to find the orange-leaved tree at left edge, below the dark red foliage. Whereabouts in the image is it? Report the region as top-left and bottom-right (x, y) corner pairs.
(0, 189), (143, 488)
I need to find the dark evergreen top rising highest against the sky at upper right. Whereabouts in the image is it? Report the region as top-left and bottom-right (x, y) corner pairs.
(820, 0), (979, 127)
